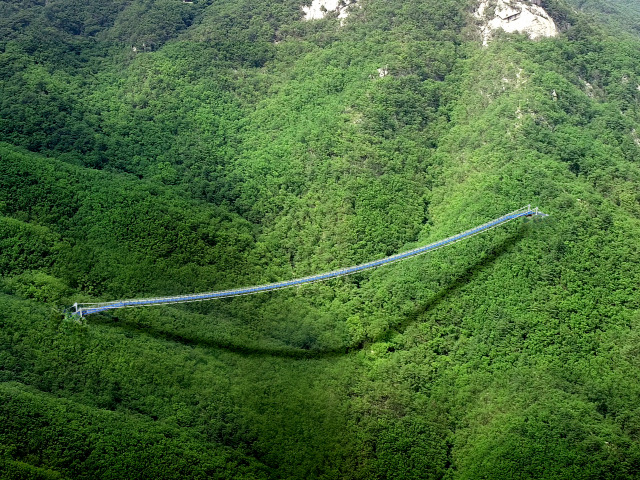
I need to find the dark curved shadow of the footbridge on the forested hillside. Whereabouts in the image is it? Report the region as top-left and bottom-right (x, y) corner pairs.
(91, 226), (528, 359)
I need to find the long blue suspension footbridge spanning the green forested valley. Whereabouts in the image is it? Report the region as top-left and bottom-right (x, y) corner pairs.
(71, 205), (548, 317)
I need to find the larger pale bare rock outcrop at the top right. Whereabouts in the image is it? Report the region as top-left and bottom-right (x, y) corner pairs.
(475, 0), (558, 45)
